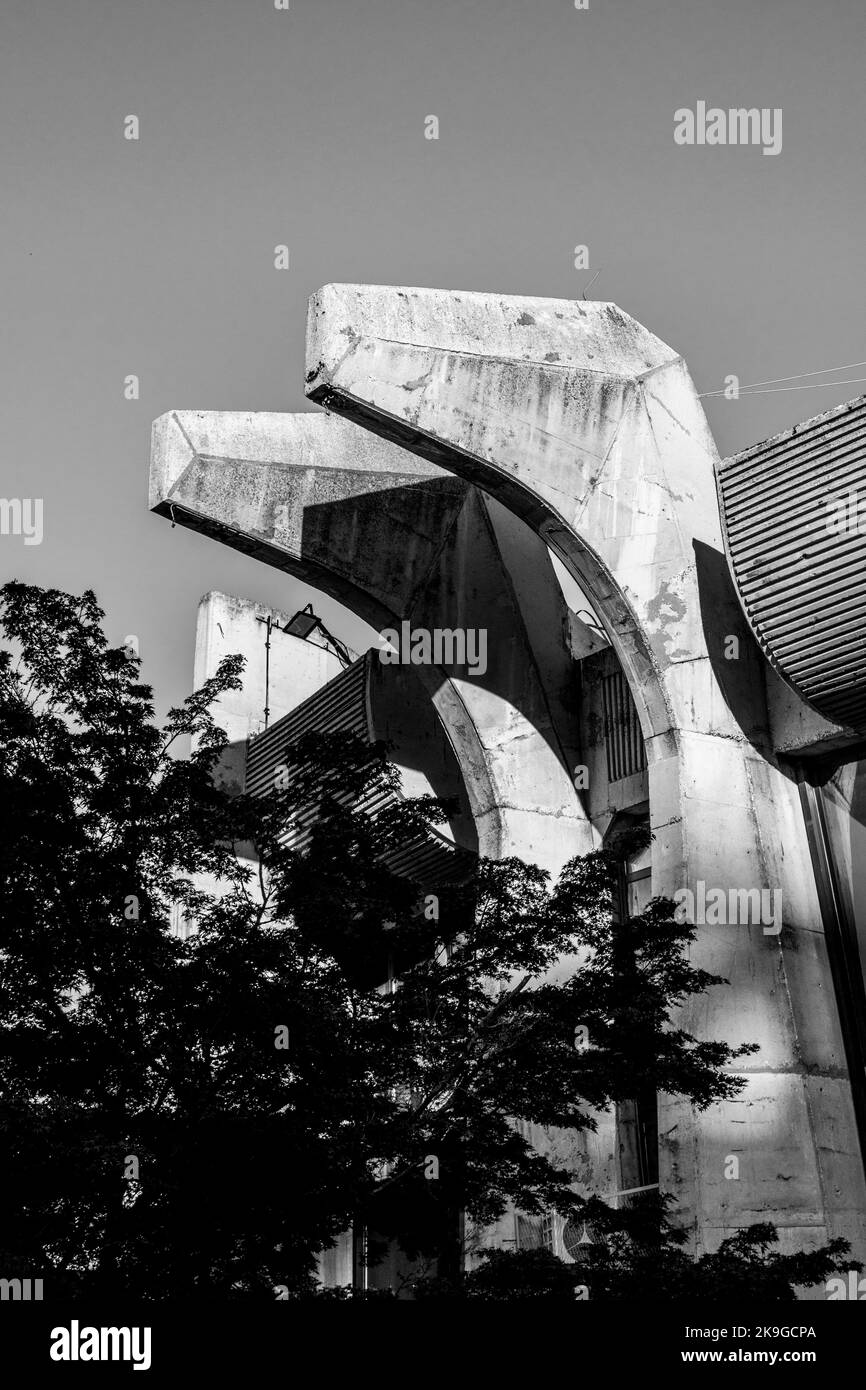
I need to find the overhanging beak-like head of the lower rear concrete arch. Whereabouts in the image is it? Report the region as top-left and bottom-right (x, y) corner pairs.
(149, 410), (466, 628)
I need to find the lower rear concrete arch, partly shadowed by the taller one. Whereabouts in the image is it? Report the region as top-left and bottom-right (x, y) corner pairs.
(150, 411), (592, 873)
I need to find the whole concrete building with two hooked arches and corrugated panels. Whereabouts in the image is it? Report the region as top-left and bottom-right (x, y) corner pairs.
(150, 285), (866, 1280)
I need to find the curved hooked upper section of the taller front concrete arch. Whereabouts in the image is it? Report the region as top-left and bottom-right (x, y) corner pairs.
(307, 285), (767, 756)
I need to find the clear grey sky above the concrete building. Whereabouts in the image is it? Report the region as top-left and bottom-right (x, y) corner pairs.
(0, 0), (866, 708)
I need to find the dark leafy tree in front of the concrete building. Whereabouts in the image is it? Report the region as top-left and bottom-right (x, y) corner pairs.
(0, 582), (856, 1298)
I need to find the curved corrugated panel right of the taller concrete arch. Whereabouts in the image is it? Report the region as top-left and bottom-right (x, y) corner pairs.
(717, 396), (866, 733)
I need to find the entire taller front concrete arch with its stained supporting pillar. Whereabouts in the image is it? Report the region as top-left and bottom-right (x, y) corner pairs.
(307, 285), (866, 1273)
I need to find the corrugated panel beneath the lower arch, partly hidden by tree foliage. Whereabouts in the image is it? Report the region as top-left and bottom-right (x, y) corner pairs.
(246, 652), (473, 887)
